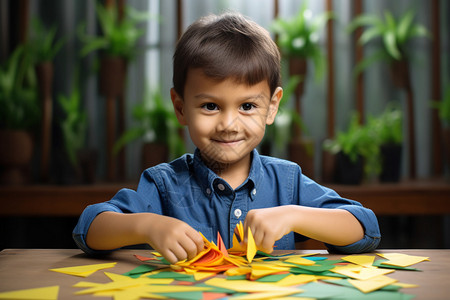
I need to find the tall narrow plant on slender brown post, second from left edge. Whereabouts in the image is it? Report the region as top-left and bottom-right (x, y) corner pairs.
(29, 19), (64, 181)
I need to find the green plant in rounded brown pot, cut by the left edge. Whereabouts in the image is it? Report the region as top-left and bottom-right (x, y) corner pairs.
(0, 45), (40, 184)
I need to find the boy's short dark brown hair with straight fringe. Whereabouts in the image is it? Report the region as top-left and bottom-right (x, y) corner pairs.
(173, 13), (281, 97)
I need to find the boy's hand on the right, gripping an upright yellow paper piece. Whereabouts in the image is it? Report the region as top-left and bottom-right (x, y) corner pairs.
(244, 206), (292, 253)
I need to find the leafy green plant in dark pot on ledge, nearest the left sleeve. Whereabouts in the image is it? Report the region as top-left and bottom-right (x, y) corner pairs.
(58, 79), (97, 184)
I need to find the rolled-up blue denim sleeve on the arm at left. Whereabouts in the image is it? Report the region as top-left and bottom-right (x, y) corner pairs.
(72, 174), (161, 254)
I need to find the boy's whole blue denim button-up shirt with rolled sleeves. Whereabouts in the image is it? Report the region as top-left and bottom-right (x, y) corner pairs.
(73, 149), (380, 254)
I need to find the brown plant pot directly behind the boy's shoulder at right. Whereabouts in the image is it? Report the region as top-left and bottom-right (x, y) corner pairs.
(288, 139), (314, 178)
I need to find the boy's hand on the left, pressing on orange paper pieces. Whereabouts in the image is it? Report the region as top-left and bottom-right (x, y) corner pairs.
(143, 215), (204, 264)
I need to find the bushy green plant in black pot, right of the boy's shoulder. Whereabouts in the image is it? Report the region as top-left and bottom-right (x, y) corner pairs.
(324, 113), (381, 184)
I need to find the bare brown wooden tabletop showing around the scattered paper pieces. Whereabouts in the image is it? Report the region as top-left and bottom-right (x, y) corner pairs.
(0, 249), (450, 300)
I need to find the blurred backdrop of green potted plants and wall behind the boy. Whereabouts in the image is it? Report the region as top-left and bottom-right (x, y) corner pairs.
(0, 0), (450, 249)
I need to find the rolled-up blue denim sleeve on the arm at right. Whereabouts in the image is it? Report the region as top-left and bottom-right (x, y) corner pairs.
(299, 170), (381, 253)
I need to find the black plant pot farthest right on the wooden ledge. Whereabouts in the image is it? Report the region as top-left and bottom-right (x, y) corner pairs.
(380, 144), (402, 182)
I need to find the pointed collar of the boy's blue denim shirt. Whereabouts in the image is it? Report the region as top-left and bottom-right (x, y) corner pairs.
(191, 148), (263, 200)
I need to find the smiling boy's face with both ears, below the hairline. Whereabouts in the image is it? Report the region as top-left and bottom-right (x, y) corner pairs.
(171, 69), (283, 168)
